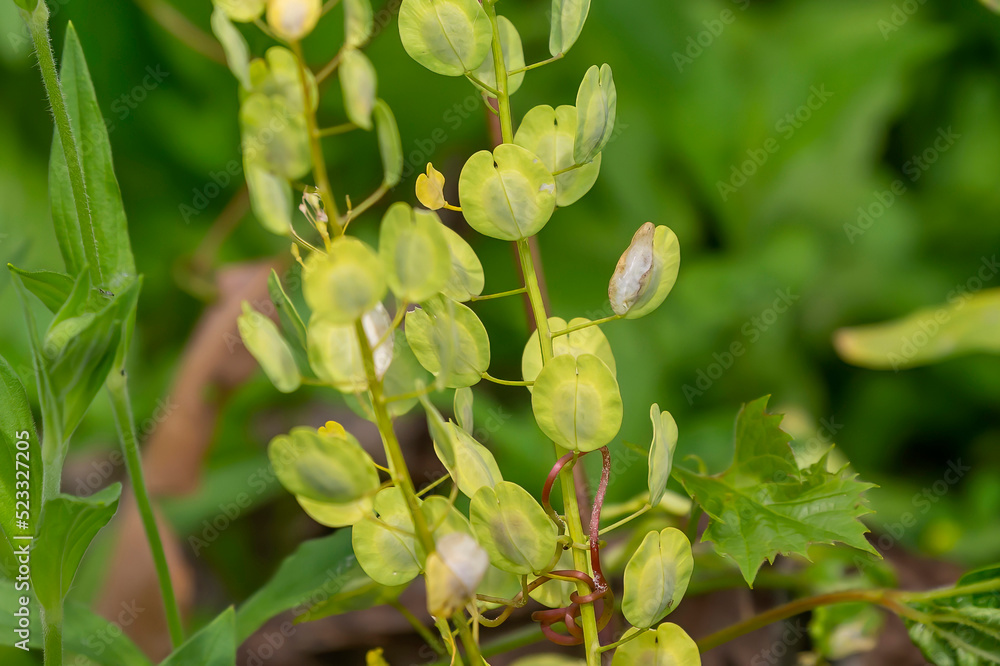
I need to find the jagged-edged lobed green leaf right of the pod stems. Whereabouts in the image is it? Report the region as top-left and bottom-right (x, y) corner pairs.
(674, 396), (875, 586)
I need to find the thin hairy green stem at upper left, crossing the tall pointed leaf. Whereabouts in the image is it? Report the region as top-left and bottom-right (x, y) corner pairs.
(21, 0), (104, 285)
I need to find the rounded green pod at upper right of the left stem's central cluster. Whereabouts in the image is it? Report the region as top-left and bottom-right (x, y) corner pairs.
(378, 201), (451, 303)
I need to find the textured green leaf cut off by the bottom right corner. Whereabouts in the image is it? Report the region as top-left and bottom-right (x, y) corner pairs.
(903, 565), (1000, 666)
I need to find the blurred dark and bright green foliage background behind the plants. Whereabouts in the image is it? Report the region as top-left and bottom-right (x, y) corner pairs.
(0, 0), (1000, 652)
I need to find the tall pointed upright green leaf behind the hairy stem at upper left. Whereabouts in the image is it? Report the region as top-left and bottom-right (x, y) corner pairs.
(49, 23), (135, 291)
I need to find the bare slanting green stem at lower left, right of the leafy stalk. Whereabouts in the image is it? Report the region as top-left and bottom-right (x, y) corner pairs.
(108, 372), (184, 648)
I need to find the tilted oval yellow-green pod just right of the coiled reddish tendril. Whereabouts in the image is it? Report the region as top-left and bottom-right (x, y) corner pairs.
(622, 527), (694, 629)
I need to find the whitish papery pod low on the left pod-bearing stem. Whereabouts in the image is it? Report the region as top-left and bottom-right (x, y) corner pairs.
(426, 532), (490, 618)
